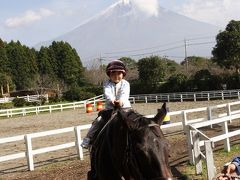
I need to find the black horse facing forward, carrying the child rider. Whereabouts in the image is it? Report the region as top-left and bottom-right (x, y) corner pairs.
(88, 103), (172, 180)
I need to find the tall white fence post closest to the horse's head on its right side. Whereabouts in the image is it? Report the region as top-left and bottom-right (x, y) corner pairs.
(182, 111), (195, 164)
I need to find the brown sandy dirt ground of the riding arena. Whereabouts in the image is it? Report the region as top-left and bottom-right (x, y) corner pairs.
(0, 100), (240, 180)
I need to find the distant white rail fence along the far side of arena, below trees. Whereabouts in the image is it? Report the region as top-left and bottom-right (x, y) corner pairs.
(0, 89), (240, 117)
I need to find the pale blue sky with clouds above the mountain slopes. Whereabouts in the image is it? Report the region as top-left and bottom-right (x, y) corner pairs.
(0, 0), (240, 47)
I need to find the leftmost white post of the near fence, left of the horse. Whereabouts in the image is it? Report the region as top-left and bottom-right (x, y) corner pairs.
(24, 134), (34, 171)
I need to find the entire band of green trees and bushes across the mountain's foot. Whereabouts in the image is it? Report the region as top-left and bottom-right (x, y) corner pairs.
(0, 20), (240, 100)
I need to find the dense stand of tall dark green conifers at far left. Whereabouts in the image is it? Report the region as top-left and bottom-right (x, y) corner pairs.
(0, 39), (85, 96)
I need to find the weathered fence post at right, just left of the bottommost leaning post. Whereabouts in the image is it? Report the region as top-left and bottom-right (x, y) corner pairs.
(191, 130), (202, 175)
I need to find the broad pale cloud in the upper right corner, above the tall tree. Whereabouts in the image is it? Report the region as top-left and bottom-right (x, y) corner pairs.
(179, 0), (240, 27)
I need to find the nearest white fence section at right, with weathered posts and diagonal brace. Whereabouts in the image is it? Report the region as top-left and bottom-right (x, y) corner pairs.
(190, 114), (240, 180)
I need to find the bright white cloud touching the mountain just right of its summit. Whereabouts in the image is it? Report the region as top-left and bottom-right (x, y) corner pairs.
(131, 0), (159, 16)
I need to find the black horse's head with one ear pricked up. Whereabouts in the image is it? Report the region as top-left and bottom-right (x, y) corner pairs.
(120, 103), (172, 179)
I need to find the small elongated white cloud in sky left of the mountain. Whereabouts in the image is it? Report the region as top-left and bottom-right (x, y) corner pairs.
(5, 8), (54, 28)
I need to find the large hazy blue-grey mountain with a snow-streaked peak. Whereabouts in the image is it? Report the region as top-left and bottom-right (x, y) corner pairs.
(36, 0), (220, 64)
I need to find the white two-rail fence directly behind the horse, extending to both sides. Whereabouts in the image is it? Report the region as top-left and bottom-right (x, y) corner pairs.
(0, 101), (240, 175)
